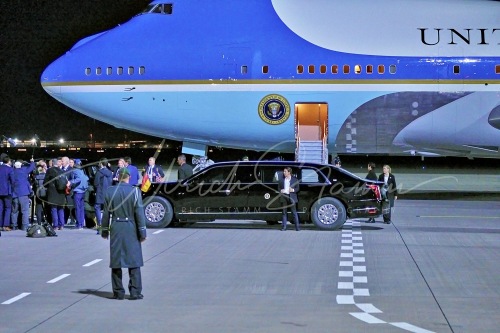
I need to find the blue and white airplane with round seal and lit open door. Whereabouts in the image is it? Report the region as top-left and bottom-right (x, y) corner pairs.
(41, 0), (500, 161)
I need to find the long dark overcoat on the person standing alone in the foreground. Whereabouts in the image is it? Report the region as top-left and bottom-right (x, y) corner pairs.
(101, 182), (146, 268)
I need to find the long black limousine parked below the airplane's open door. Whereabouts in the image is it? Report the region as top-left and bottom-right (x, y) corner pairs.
(143, 161), (389, 230)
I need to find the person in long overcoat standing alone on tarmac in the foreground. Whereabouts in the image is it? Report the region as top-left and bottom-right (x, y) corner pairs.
(101, 168), (146, 300)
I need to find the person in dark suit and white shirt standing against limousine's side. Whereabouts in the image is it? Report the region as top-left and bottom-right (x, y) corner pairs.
(278, 167), (300, 231)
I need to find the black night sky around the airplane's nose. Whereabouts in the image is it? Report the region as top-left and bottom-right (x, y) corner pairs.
(0, 0), (152, 141)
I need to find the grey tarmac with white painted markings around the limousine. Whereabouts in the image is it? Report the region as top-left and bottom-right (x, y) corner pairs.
(0, 170), (500, 333)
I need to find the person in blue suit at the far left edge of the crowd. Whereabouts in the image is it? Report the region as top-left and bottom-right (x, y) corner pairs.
(0, 154), (14, 235)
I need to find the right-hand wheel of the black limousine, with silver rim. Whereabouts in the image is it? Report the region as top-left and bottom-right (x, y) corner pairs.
(311, 198), (347, 230)
